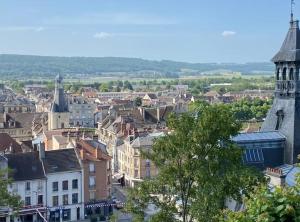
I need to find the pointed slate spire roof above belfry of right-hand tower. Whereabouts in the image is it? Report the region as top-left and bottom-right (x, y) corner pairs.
(272, 21), (300, 62)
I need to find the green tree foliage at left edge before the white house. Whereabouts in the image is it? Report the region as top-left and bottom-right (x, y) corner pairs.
(0, 170), (21, 210)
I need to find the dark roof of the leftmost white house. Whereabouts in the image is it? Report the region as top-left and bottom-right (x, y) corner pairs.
(5, 152), (45, 181)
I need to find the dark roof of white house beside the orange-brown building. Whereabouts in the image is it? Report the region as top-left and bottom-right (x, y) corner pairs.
(43, 149), (81, 173)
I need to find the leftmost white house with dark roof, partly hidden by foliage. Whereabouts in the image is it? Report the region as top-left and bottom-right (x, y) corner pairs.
(5, 152), (47, 222)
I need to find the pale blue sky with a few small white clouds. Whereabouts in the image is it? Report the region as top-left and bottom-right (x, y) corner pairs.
(0, 0), (300, 63)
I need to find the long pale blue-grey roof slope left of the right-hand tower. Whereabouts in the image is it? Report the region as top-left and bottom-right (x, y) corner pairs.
(232, 131), (286, 143)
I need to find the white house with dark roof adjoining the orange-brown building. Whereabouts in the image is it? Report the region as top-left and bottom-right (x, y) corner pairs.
(40, 148), (84, 221)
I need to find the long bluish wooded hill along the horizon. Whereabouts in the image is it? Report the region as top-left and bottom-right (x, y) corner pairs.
(0, 54), (274, 78)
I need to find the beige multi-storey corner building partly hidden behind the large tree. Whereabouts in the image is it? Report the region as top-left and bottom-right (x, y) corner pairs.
(117, 132), (164, 187)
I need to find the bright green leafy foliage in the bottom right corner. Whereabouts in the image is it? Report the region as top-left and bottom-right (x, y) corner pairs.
(224, 175), (300, 222)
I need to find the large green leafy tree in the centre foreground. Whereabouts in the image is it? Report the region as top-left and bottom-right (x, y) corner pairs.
(127, 105), (263, 222)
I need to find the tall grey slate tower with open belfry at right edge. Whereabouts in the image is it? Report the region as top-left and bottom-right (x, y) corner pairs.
(261, 13), (300, 164)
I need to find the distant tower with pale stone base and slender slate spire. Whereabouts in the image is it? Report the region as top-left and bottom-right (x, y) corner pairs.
(48, 75), (70, 130)
